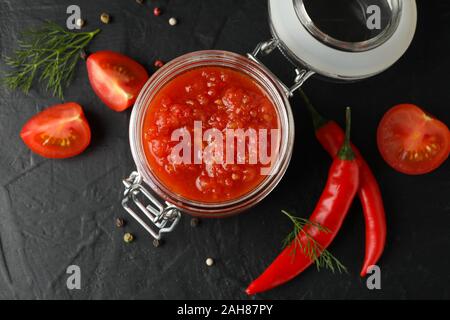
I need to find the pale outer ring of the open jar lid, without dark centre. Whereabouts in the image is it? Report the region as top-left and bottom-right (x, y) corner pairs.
(268, 0), (417, 81)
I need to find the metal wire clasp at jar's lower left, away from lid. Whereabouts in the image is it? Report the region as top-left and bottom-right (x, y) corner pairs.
(122, 171), (181, 240)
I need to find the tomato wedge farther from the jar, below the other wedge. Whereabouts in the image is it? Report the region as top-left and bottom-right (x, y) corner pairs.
(20, 102), (91, 159)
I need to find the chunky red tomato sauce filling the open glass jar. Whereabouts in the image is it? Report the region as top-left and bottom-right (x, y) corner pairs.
(142, 67), (279, 203)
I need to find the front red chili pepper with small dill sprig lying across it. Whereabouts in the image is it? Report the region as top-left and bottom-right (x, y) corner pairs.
(246, 109), (359, 295)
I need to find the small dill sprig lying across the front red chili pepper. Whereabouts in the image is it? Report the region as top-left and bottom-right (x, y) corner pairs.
(281, 210), (347, 273)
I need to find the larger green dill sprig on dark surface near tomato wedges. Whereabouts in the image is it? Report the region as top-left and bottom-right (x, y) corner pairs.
(2, 21), (100, 99)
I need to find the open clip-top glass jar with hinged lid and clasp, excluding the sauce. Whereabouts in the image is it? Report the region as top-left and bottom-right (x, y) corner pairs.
(122, 0), (417, 239)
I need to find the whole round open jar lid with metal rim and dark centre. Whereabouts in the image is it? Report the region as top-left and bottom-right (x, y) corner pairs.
(269, 0), (417, 80)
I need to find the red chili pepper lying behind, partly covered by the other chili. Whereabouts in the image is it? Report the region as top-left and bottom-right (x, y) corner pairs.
(300, 90), (386, 277)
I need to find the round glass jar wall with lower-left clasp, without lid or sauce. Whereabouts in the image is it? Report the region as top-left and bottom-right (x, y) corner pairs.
(122, 50), (295, 239)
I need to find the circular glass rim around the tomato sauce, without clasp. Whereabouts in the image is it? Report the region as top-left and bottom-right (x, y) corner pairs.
(129, 50), (295, 217)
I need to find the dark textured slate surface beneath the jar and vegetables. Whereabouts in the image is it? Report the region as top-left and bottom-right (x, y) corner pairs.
(0, 0), (450, 299)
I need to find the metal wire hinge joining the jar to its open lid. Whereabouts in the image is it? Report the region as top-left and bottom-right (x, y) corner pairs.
(247, 39), (315, 98)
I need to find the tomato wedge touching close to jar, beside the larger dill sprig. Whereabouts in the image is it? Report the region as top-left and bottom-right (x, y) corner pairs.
(86, 51), (149, 112)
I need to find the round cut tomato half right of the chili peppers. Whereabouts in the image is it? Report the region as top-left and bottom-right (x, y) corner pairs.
(377, 104), (450, 175)
